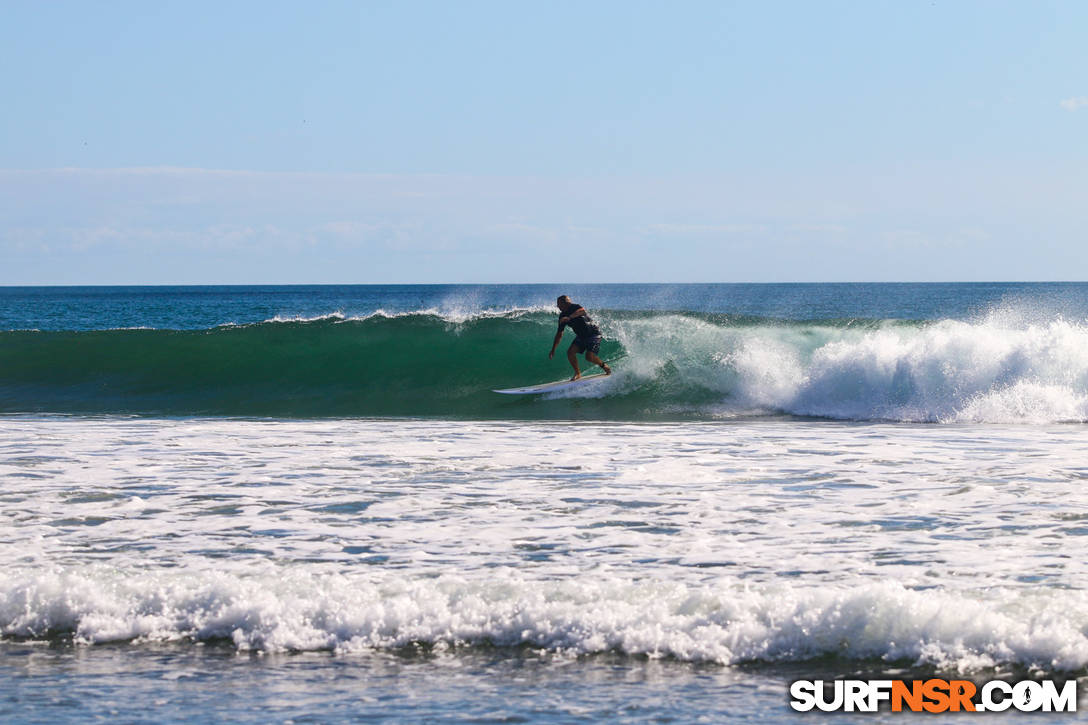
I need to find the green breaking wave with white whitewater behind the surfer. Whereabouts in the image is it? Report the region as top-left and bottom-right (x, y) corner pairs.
(0, 310), (1088, 423)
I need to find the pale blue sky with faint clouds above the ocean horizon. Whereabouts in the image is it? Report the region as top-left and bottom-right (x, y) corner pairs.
(0, 0), (1088, 285)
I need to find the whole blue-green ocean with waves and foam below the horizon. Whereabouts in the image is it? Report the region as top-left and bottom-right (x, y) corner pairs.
(0, 283), (1088, 723)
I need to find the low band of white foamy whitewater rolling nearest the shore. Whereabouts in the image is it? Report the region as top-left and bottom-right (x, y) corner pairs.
(0, 570), (1088, 672)
